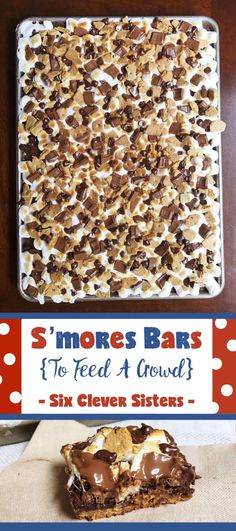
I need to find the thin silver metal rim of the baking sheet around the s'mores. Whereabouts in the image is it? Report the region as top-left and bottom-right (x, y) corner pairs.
(16, 15), (225, 304)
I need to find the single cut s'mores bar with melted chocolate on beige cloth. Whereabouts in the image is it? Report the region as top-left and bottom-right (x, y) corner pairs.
(61, 424), (196, 520)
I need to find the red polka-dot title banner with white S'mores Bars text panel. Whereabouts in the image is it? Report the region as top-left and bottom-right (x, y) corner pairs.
(0, 320), (236, 415)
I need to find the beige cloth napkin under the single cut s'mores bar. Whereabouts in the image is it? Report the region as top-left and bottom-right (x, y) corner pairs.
(0, 420), (236, 522)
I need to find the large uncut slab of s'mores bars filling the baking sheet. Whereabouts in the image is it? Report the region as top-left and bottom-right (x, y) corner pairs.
(17, 17), (225, 303)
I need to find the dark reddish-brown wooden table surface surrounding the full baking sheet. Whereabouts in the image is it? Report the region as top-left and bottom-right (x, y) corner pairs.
(0, 0), (236, 312)
